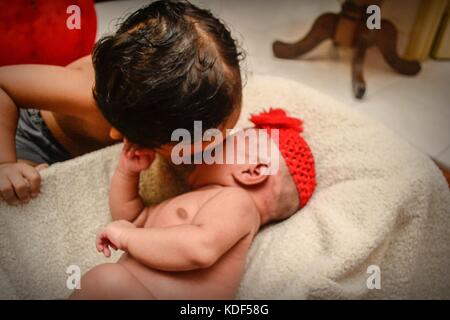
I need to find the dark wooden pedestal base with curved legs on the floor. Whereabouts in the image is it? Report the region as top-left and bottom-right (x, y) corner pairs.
(272, 0), (420, 99)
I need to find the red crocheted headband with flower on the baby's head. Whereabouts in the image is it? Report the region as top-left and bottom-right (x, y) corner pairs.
(250, 108), (316, 208)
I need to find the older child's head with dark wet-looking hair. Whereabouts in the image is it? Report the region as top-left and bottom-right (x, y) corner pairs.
(93, 1), (242, 149)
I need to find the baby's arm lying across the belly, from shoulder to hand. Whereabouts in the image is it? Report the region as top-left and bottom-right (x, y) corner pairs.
(97, 188), (259, 271)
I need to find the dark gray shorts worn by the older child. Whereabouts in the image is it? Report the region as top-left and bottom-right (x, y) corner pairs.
(16, 109), (73, 164)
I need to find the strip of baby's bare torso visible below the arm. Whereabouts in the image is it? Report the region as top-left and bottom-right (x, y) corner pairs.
(119, 249), (245, 300)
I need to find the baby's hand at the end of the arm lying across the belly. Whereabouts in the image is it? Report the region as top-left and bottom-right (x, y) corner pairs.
(95, 220), (136, 258)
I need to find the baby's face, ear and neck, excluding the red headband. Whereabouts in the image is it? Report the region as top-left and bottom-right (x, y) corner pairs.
(188, 129), (300, 223)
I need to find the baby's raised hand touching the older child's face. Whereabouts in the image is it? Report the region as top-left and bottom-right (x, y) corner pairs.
(119, 139), (155, 174)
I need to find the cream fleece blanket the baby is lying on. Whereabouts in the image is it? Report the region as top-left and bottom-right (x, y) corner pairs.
(0, 77), (450, 299)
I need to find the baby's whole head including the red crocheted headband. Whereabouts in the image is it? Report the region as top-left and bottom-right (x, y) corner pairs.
(189, 109), (316, 223)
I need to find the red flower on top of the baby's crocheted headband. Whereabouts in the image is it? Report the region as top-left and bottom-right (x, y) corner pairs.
(250, 108), (303, 132)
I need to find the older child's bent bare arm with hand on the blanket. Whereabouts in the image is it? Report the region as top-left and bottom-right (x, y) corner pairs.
(0, 60), (99, 204)
